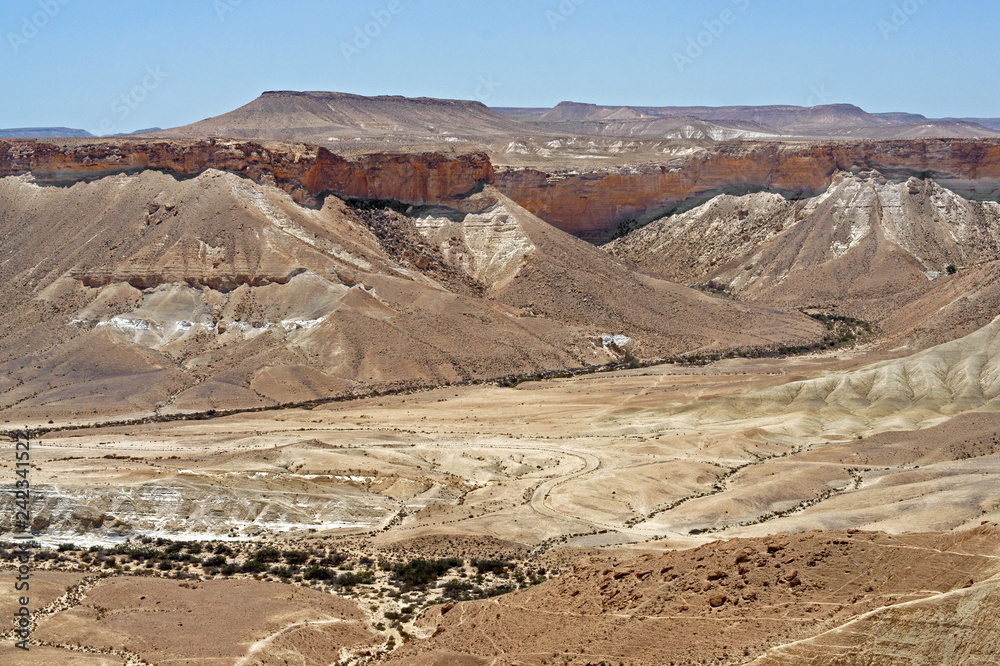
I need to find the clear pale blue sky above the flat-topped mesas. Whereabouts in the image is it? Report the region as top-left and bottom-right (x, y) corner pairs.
(0, 0), (1000, 133)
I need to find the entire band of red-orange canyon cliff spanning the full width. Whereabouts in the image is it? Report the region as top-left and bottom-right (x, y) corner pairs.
(0, 139), (1000, 242)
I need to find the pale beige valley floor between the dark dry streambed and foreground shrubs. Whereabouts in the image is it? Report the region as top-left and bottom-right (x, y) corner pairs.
(6, 322), (1000, 545)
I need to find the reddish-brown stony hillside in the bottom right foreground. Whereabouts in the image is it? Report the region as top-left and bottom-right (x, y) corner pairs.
(386, 524), (1000, 666)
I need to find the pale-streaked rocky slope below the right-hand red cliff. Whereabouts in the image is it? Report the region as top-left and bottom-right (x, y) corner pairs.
(606, 173), (1000, 332)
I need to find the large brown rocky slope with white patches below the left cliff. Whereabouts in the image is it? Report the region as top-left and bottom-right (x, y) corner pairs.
(0, 170), (821, 418)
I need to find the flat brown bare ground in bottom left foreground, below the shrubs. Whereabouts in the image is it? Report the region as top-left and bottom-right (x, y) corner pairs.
(34, 577), (375, 665)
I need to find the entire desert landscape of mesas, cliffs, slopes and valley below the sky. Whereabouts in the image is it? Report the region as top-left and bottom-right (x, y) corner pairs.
(0, 0), (1000, 666)
